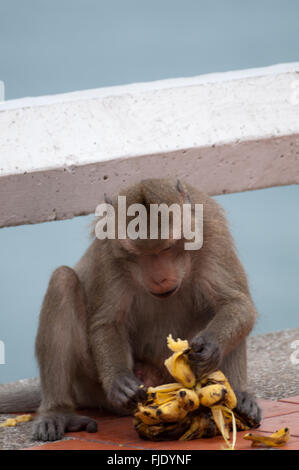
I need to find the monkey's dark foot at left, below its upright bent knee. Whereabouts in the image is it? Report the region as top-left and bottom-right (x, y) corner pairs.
(33, 413), (98, 441)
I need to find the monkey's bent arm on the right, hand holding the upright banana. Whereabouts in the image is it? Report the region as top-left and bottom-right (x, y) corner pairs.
(190, 252), (257, 375)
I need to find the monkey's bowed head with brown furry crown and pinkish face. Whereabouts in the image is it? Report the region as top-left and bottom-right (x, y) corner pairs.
(110, 179), (195, 299)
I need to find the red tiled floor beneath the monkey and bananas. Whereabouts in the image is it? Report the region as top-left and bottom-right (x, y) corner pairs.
(24, 397), (299, 450)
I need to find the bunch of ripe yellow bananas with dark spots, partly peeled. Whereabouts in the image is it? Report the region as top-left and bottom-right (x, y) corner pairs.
(134, 335), (251, 448)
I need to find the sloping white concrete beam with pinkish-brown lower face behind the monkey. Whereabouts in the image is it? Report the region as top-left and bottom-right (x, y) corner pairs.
(0, 63), (299, 226)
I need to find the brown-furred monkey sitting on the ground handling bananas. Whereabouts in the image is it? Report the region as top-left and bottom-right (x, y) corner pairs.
(0, 178), (261, 441)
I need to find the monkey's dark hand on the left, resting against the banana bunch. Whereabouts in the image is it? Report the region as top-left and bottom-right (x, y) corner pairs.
(107, 370), (147, 410)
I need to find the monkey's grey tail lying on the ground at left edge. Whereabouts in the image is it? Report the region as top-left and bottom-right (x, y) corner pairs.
(0, 379), (41, 413)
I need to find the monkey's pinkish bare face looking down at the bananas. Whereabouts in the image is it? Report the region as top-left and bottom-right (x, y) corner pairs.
(118, 240), (191, 299)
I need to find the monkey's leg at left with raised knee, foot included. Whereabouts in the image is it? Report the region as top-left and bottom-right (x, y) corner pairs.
(33, 266), (97, 441)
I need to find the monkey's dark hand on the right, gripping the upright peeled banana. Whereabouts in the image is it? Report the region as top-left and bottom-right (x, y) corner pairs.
(188, 335), (222, 380)
